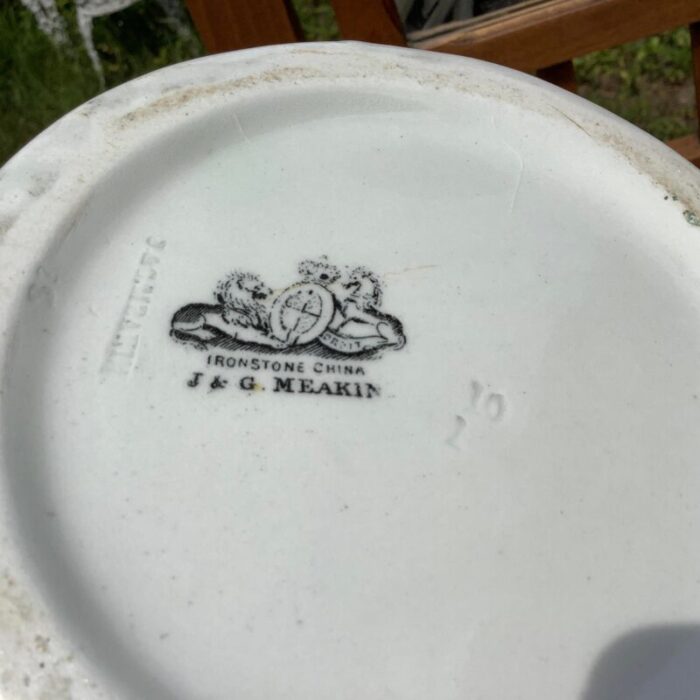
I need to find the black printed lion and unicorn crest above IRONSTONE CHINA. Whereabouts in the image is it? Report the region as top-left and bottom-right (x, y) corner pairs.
(170, 256), (406, 359)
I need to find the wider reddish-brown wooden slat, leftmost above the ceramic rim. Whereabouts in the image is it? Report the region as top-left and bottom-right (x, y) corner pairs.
(187, 0), (303, 53)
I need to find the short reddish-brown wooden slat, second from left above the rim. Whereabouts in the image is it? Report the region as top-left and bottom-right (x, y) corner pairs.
(332, 0), (406, 46)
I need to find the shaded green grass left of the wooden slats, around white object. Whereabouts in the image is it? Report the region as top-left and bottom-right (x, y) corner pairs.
(0, 0), (203, 163)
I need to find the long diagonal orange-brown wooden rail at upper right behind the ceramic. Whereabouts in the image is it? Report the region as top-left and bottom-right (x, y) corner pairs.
(411, 0), (700, 71)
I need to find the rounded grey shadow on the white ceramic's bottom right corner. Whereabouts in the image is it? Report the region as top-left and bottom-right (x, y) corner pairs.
(581, 624), (700, 700)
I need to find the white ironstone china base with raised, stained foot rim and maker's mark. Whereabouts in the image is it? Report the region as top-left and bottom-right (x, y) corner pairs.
(0, 44), (700, 700)
